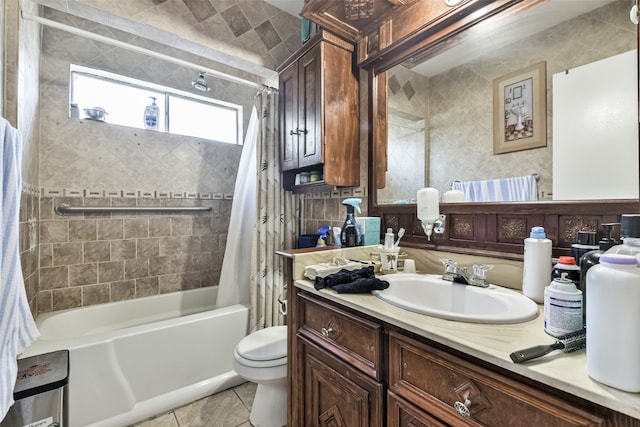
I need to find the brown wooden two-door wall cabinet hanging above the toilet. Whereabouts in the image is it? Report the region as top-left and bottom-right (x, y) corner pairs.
(278, 31), (360, 190)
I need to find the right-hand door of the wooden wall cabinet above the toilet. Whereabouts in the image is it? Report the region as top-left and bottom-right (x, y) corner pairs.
(298, 43), (323, 168)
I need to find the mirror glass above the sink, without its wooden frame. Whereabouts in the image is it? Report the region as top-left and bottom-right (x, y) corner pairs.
(369, 0), (639, 205)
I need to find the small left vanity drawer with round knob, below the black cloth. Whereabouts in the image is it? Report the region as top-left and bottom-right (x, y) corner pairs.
(298, 293), (382, 380)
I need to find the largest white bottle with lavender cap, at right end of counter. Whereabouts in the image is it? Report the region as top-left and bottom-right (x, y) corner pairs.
(586, 253), (640, 393)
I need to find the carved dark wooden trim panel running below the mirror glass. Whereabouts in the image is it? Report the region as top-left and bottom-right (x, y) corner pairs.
(368, 196), (640, 260)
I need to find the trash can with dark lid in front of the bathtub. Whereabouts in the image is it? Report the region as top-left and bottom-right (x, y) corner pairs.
(0, 350), (69, 427)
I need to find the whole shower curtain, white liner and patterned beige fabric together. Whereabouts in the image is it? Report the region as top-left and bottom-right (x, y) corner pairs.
(217, 91), (297, 332)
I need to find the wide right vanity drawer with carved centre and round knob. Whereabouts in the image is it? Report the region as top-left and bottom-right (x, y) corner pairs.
(389, 332), (604, 427)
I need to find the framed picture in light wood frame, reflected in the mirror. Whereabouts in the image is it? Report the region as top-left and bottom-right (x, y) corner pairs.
(493, 61), (547, 154)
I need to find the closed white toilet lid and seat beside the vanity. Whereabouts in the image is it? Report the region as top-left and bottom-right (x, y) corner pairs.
(234, 326), (287, 368)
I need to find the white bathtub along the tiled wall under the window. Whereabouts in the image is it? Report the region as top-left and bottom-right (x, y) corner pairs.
(21, 287), (249, 427)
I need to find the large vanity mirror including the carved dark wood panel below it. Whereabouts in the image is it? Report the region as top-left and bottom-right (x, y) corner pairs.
(364, 0), (640, 259)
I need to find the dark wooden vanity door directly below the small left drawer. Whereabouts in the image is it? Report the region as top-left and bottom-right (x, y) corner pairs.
(302, 339), (384, 427)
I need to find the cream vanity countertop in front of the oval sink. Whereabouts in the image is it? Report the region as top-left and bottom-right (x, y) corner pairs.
(295, 280), (640, 419)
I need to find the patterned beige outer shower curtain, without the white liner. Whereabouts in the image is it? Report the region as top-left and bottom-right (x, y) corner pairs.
(249, 90), (298, 332)
